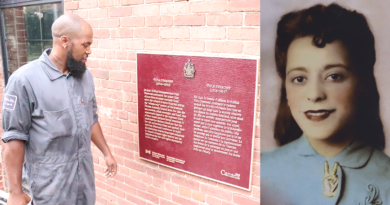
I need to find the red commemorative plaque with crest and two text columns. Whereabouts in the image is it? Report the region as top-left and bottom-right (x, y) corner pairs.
(137, 54), (258, 190)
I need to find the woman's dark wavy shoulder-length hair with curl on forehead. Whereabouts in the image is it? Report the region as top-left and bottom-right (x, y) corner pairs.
(274, 3), (385, 150)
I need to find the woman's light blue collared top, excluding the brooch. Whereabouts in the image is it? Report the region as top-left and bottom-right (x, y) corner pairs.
(261, 135), (390, 205)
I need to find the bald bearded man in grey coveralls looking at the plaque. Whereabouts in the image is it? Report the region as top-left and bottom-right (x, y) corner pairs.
(2, 14), (117, 205)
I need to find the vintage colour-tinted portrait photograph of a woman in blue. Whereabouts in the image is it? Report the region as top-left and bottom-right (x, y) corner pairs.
(261, 0), (390, 205)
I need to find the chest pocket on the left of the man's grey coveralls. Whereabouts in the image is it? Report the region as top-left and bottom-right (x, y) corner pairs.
(42, 108), (74, 140)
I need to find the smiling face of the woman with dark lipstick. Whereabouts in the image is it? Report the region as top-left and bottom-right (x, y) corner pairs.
(286, 36), (358, 140)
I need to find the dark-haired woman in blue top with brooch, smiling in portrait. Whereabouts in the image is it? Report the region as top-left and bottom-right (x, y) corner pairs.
(261, 4), (390, 205)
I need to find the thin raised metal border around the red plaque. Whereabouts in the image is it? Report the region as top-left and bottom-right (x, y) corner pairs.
(136, 51), (260, 191)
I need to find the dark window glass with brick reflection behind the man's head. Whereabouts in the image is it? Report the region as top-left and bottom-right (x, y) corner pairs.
(3, 3), (64, 74)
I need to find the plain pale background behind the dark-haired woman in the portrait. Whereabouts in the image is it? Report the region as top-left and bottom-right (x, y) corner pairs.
(260, 0), (390, 156)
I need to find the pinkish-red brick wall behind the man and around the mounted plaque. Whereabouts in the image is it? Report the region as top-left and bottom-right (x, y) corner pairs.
(65, 0), (260, 205)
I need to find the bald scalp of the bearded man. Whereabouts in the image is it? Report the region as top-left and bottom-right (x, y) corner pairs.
(51, 14), (91, 40)
